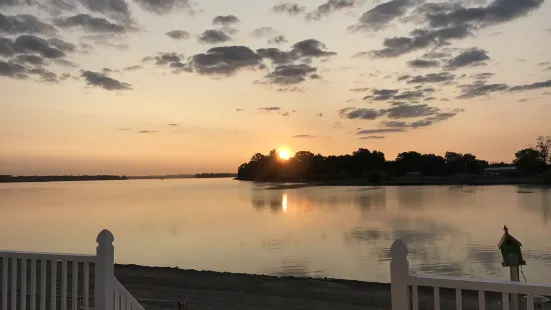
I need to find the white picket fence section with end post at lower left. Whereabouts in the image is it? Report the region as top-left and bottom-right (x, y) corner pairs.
(0, 229), (144, 310)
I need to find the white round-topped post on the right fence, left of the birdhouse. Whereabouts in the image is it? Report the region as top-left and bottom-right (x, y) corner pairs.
(390, 239), (409, 310)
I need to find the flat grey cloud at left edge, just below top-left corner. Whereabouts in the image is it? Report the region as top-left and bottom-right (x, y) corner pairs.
(0, 13), (57, 35)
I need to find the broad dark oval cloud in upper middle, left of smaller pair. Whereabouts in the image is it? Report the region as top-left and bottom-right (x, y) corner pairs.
(189, 46), (264, 75)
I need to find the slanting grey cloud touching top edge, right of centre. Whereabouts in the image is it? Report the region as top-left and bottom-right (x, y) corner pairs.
(348, 0), (417, 31)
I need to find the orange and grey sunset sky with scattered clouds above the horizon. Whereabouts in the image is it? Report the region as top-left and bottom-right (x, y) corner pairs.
(0, 0), (551, 175)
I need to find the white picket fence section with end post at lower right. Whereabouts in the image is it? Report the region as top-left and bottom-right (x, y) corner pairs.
(390, 239), (551, 310)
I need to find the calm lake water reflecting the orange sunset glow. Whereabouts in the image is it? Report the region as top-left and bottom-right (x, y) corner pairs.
(0, 179), (551, 282)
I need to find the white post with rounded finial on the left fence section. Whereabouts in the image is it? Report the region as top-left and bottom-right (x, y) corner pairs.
(94, 229), (115, 310)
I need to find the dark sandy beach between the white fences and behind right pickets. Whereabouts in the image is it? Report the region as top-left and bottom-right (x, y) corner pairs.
(115, 265), (501, 310)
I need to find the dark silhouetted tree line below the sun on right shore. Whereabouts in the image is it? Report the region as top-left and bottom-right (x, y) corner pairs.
(237, 136), (551, 182)
